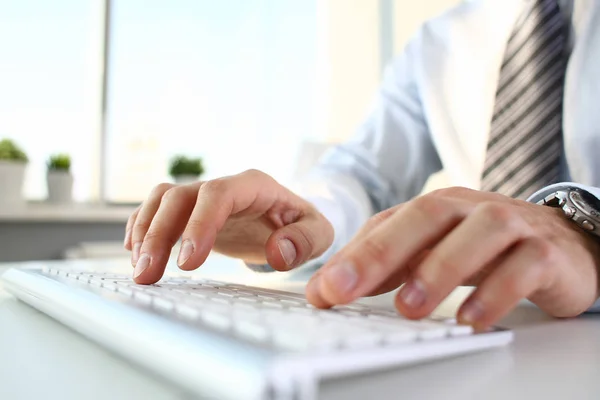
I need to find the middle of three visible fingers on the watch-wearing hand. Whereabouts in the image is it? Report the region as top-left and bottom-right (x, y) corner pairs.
(398, 202), (531, 318)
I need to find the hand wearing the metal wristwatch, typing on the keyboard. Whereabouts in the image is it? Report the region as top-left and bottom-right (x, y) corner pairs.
(307, 188), (600, 329)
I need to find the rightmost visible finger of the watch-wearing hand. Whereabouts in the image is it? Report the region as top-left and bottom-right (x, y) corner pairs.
(458, 238), (561, 330)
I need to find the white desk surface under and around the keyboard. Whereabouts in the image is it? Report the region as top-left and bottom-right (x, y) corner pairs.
(0, 257), (600, 400)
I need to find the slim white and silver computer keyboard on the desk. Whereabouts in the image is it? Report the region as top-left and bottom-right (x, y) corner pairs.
(2, 268), (512, 399)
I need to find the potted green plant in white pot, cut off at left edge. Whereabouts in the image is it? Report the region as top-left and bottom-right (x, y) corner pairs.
(0, 139), (29, 207)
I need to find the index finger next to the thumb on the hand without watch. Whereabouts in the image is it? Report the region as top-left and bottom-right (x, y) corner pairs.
(178, 171), (296, 270)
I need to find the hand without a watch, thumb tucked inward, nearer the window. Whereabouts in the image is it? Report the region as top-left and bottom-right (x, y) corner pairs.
(125, 170), (333, 284)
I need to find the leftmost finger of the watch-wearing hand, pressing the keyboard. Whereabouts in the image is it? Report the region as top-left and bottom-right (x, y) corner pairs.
(319, 196), (473, 304)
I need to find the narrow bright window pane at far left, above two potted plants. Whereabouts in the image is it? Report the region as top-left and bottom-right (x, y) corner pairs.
(0, 0), (99, 200)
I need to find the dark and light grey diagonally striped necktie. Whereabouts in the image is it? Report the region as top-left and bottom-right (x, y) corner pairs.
(481, 0), (567, 199)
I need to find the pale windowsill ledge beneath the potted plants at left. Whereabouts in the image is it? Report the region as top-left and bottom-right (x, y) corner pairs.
(0, 202), (135, 224)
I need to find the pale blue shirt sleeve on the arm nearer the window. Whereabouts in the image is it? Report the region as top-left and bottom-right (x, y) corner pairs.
(250, 33), (442, 271)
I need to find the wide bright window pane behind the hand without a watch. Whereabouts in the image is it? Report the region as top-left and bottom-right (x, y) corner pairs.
(105, 0), (323, 202)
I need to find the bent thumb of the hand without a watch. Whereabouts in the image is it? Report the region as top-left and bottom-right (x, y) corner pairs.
(265, 213), (333, 271)
